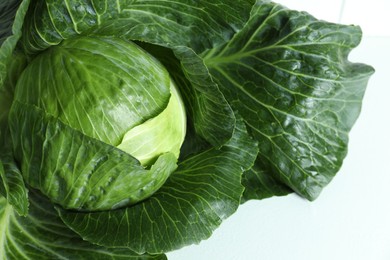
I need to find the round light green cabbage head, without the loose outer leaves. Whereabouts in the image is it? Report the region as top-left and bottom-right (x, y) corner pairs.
(10, 37), (186, 211)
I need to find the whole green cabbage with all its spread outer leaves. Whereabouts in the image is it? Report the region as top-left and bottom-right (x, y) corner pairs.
(0, 0), (373, 259)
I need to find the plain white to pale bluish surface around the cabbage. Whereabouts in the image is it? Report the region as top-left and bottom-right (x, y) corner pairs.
(167, 0), (390, 260)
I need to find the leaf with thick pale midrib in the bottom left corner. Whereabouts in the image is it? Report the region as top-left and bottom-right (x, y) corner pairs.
(0, 190), (166, 260)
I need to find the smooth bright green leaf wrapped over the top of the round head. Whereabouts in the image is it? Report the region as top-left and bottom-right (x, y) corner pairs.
(14, 37), (170, 146)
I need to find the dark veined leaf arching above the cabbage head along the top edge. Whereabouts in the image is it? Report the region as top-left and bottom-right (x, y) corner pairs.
(23, 0), (252, 53)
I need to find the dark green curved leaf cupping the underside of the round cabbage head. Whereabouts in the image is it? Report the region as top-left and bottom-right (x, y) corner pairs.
(58, 116), (258, 254)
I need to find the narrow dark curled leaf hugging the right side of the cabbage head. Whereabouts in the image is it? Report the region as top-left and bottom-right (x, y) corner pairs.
(139, 43), (235, 148)
